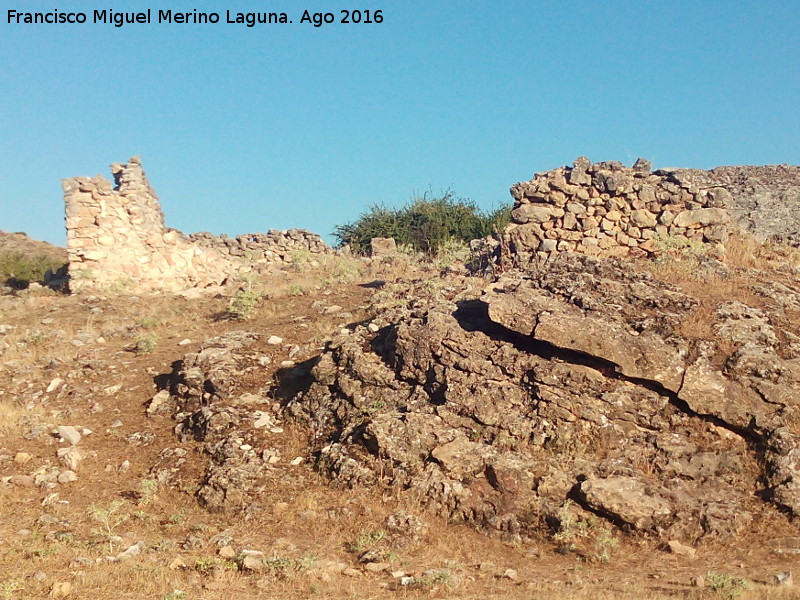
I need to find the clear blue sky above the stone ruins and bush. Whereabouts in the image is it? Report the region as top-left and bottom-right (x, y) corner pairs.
(0, 0), (800, 245)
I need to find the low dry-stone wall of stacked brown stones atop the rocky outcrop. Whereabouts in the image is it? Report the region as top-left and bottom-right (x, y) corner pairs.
(502, 157), (732, 262)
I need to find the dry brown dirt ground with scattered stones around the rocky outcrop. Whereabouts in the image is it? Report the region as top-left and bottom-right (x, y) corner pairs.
(0, 258), (800, 600)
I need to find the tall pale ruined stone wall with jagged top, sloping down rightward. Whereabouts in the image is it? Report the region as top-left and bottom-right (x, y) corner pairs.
(62, 157), (333, 292)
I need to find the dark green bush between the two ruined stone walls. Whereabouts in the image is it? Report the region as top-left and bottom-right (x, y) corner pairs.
(333, 190), (510, 254)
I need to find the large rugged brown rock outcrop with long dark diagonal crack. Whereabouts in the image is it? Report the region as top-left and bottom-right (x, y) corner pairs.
(289, 254), (800, 539)
